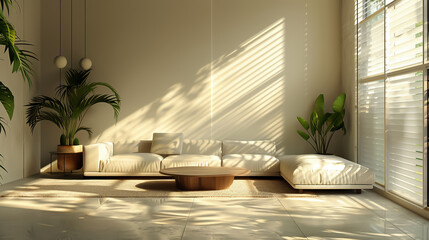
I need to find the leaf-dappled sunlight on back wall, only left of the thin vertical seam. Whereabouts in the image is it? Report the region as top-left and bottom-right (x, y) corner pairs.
(93, 63), (210, 142)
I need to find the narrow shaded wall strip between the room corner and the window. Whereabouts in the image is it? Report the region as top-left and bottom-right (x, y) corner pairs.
(340, 0), (357, 162)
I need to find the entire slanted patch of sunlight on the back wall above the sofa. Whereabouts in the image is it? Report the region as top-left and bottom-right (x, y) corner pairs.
(93, 19), (285, 152)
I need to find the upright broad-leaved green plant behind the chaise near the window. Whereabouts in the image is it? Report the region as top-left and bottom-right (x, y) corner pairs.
(297, 93), (346, 154)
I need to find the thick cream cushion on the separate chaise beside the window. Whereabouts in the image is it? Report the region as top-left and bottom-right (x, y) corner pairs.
(280, 154), (374, 185)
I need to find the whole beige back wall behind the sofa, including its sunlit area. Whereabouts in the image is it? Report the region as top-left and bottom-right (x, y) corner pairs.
(42, 0), (341, 163)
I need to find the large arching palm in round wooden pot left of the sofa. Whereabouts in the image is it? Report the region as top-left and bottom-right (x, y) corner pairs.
(26, 69), (121, 170)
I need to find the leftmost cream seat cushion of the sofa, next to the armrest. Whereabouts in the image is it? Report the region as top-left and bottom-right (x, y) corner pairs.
(100, 153), (162, 172)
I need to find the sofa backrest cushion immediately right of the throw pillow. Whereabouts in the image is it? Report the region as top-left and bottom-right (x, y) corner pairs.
(182, 139), (222, 157)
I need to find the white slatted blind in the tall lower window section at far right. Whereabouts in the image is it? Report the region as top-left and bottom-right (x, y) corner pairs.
(386, 72), (423, 205)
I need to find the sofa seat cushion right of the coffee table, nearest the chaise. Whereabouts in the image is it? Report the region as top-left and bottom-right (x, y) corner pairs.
(222, 154), (280, 173)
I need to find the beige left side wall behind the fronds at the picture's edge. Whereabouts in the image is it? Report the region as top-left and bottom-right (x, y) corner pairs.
(0, 0), (41, 183)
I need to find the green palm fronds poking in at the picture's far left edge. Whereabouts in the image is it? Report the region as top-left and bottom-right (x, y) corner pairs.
(0, 0), (37, 180)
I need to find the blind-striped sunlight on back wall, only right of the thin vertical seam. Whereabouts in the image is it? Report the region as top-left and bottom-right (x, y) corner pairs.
(212, 19), (285, 152)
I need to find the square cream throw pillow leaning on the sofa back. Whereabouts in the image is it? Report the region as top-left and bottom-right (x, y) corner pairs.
(150, 133), (183, 155)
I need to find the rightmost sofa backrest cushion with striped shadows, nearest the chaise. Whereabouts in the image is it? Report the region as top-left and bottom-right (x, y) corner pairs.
(222, 140), (276, 156)
